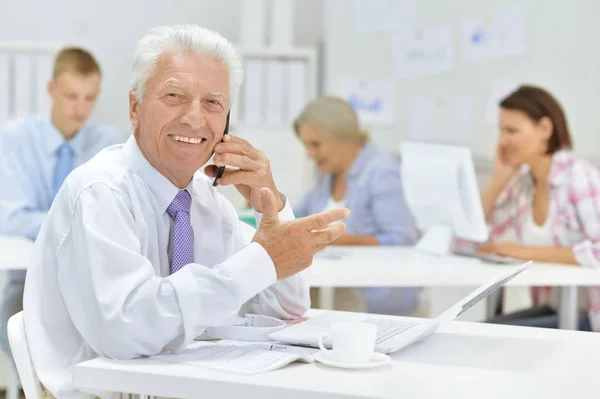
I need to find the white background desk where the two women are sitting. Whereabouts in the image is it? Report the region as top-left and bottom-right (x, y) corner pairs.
(311, 247), (600, 330)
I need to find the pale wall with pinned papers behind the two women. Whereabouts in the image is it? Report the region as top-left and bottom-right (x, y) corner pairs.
(324, 0), (600, 162)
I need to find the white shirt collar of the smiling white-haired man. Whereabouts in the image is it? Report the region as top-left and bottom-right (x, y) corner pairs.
(123, 135), (188, 213)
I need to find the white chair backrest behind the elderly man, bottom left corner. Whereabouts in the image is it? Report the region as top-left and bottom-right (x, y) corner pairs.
(7, 312), (44, 399)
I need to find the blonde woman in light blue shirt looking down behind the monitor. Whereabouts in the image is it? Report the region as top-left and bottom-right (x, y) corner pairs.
(294, 96), (419, 315)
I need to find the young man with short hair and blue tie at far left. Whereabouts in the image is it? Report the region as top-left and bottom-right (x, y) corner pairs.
(0, 48), (125, 362)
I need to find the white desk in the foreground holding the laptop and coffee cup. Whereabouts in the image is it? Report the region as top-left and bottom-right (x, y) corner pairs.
(74, 311), (600, 399)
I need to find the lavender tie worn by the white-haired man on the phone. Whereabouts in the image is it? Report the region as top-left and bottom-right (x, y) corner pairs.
(167, 190), (194, 273)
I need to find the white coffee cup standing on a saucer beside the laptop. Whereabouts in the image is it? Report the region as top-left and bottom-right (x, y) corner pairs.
(319, 323), (377, 363)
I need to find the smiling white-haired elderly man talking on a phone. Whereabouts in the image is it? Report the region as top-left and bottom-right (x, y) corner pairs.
(24, 26), (349, 397)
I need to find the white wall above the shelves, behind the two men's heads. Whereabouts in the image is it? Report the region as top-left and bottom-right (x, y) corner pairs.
(0, 0), (322, 130)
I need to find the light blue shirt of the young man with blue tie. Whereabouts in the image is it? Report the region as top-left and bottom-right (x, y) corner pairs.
(0, 116), (125, 280)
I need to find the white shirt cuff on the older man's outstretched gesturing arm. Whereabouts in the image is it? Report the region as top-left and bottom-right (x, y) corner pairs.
(220, 242), (277, 303)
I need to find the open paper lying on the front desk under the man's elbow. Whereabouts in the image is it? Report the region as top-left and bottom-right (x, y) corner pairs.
(150, 341), (313, 375)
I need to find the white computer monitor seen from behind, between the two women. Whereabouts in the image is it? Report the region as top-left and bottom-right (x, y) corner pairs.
(400, 142), (488, 255)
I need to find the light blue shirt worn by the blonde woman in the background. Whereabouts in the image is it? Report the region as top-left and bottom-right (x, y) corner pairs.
(294, 143), (417, 245)
